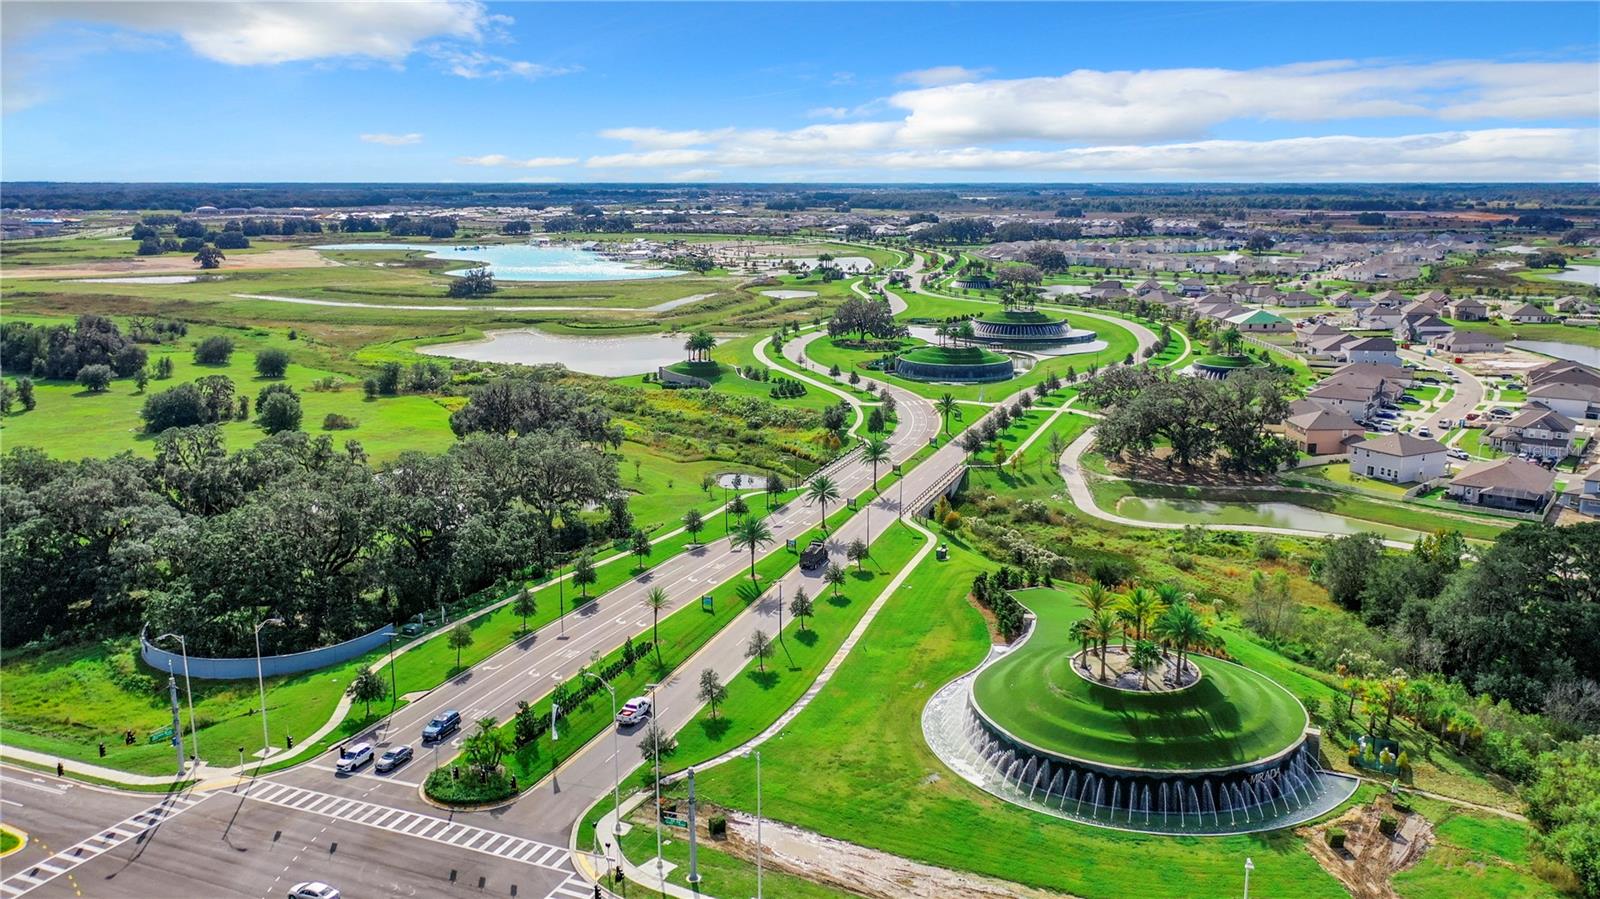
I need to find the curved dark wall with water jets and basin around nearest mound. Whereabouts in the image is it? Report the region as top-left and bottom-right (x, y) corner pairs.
(922, 636), (1358, 835)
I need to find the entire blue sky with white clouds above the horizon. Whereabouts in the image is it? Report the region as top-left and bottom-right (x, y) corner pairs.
(0, 0), (1600, 181)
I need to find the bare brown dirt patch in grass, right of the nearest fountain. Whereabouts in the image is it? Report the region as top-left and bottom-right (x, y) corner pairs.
(1296, 797), (1434, 899)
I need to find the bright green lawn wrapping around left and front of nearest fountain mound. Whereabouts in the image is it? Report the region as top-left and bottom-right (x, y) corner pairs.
(698, 534), (1344, 899)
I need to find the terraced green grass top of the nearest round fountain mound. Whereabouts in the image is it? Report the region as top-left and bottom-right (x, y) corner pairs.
(973, 590), (1309, 771)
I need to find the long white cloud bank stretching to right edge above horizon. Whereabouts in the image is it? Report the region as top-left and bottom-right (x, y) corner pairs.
(584, 61), (1600, 181)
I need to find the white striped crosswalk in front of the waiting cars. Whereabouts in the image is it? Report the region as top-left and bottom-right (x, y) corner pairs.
(245, 781), (571, 870)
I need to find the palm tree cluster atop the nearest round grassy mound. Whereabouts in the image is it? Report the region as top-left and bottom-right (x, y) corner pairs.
(1072, 581), (1221, 689)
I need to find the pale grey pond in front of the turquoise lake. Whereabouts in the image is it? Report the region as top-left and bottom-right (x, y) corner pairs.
(418, 328), (685, 378)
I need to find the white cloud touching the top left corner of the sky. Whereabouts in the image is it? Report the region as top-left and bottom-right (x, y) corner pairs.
(3, 0), (499, 66)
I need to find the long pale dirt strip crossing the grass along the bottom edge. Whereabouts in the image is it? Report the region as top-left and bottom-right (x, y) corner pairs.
(718, 813), (1070, 899)
